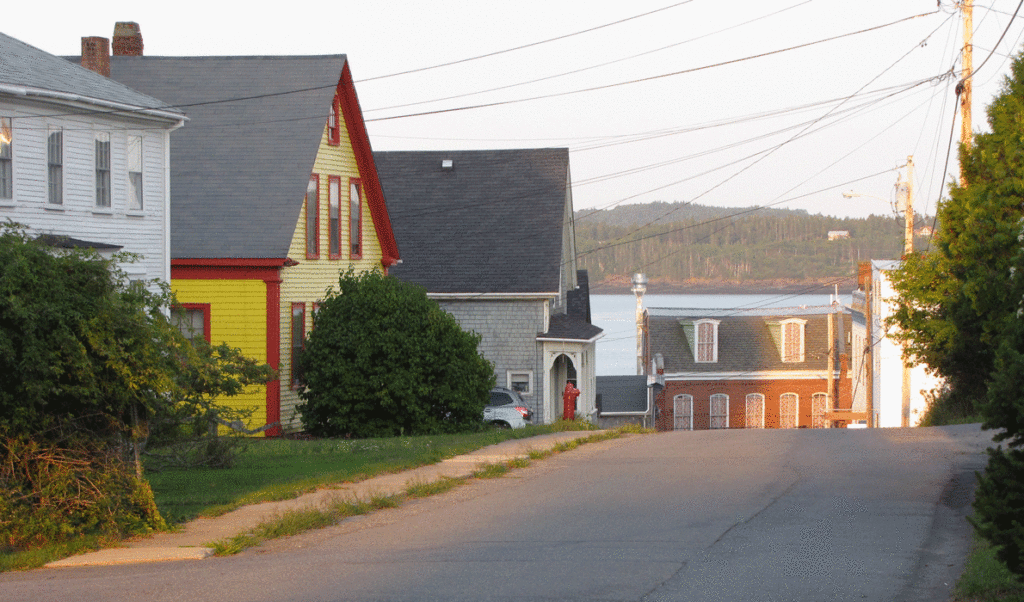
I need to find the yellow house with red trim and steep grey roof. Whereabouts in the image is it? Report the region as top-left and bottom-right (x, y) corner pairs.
(111, 44), (399, 435)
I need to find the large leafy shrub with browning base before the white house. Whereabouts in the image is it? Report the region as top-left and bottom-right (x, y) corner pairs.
(0, 222), (272, 546)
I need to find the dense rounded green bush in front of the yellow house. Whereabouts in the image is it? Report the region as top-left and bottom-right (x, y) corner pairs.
(298, 270), (495, 437)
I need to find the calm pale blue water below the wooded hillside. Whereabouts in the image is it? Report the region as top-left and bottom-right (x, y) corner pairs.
(590, 294), (850, 376)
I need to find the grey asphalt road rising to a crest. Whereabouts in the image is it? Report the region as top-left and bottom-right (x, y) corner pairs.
(0, 426), (989, 602)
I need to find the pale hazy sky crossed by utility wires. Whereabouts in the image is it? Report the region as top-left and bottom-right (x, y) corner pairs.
(8, 0), (1024, 217)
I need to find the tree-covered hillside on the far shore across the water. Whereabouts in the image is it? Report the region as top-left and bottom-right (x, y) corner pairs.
(575, 203), (930, 286)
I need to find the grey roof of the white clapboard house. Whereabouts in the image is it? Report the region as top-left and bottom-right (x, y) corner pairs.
(0, 34), (182, 121)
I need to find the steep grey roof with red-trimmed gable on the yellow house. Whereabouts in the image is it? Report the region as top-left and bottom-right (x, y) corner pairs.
(103, 54), (398, 261)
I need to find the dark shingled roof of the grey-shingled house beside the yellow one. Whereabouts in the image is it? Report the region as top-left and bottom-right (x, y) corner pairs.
(374, 148), (569, 295)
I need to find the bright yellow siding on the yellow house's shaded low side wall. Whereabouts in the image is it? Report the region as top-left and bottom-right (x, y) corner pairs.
(171, 278), (266, 429)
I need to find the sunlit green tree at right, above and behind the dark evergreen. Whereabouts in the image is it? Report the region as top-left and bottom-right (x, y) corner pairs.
(893, 54), (1024, 416)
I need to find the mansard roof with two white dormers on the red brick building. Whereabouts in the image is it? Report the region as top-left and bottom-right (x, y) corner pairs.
(647, 305), (850, 374)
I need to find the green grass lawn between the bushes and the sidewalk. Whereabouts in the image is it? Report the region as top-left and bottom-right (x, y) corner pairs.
(146, 423), (602, 522)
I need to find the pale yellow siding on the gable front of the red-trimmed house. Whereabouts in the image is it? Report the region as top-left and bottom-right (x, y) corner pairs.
(281, 115), (381, 432)
